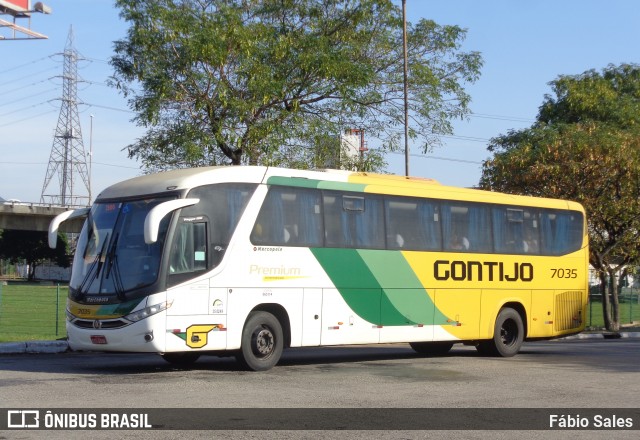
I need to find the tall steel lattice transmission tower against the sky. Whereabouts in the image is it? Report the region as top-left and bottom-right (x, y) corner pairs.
(40, 28), (91, 206)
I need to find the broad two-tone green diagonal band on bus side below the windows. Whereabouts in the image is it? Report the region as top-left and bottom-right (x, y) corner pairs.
(311, 248), (447, 326)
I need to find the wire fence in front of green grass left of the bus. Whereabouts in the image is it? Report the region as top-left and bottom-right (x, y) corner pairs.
(0, 281), (68, 342)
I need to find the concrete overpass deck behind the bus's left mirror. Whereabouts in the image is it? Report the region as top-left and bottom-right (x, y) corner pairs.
(0, 202), (84, 232)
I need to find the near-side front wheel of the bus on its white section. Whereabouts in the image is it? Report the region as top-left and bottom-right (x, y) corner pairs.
(236, 312), (284, 371)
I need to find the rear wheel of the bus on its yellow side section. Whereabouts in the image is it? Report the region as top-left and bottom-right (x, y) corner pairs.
(476, 308), (524, 357)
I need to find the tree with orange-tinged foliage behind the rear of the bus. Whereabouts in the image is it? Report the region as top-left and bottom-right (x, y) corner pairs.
(480, 64), (640, 331)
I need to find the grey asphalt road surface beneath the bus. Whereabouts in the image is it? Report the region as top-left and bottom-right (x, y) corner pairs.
(0, 339), (640, 438)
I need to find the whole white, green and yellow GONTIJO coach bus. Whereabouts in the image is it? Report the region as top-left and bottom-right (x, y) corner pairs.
(49, 167), (588, 370)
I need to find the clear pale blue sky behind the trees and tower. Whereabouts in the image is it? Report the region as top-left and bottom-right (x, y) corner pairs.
(0, 0), (640, 202)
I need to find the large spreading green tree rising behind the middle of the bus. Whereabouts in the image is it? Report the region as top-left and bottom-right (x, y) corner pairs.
(111, 0), (482, 171)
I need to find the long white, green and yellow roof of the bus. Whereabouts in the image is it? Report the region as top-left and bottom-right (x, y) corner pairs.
(97, 166), (584, 211)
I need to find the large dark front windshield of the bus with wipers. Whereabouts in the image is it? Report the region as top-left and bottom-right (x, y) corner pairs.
(69, 198), (171, 299)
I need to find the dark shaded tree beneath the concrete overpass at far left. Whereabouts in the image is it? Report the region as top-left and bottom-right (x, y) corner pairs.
(0, 229), (70, 281)
